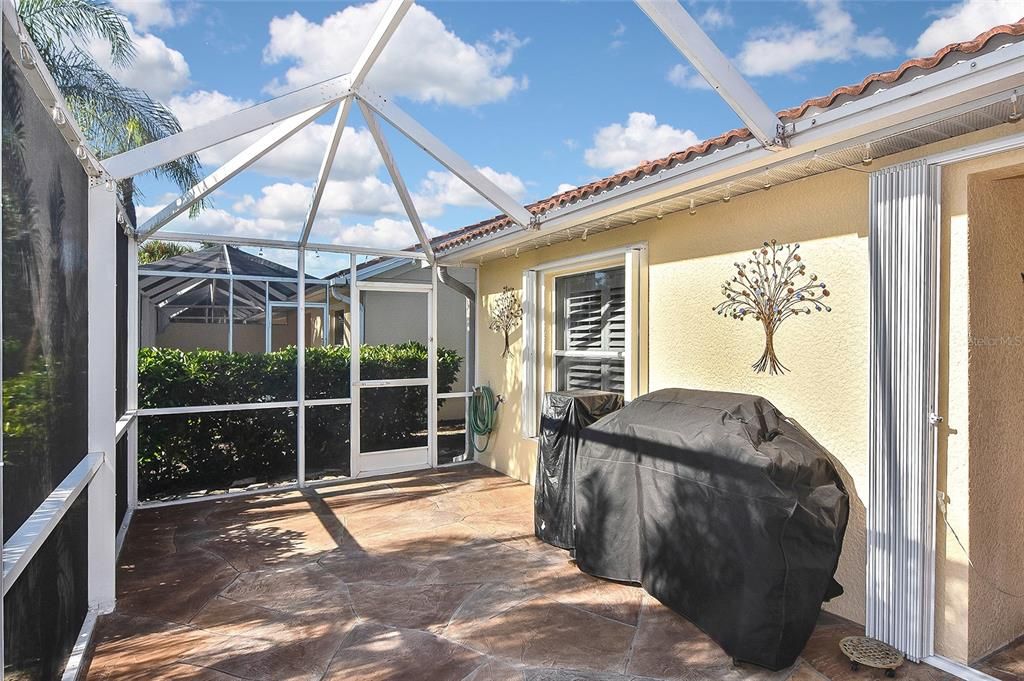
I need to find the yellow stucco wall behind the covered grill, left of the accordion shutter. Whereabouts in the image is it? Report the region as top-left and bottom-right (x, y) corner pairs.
(480, 161), (868, 621)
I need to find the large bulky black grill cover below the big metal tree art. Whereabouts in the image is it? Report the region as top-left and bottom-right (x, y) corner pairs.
(575, 389), (850, 670)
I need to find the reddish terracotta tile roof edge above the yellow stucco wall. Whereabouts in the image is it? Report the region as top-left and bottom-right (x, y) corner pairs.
(428, 17), (1024, 258)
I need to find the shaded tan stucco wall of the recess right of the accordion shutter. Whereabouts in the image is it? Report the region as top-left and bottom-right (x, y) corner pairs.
(968, 154), (1024, 659)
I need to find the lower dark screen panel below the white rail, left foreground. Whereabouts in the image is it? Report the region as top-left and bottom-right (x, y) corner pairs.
(3, 490), (89, 681)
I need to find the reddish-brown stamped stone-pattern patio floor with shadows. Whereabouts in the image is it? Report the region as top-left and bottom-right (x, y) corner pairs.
(88, 465), (952, 681)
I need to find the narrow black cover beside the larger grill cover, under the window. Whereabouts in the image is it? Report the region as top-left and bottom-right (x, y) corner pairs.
(534, 390), (623, 549)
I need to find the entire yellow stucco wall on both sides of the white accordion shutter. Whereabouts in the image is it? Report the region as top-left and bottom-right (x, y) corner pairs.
(478, 126), (1024, 661)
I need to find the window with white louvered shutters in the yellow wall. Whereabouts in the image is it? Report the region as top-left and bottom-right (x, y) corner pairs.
(554, 267), (627, 393)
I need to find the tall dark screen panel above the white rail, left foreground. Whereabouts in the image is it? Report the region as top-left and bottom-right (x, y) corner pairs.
(2, 49), (88, 541)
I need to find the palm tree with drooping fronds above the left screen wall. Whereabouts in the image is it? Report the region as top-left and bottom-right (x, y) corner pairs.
(17, 0), (202, 224)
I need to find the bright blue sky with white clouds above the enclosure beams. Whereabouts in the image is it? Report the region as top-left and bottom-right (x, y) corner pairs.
(91, 0), (1024, 258)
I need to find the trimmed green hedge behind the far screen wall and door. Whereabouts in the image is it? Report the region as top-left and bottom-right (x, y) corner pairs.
(138, 343), (462, 499)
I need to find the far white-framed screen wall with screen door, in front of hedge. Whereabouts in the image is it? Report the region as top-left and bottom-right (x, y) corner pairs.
(133, 245), (475, 502)
